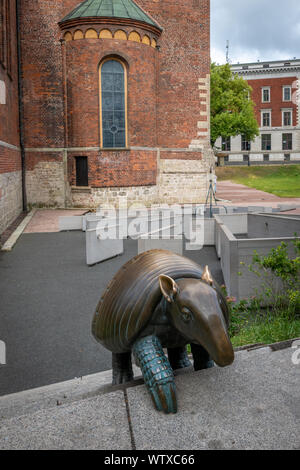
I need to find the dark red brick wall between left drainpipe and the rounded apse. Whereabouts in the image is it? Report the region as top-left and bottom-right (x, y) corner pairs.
(21, 0), (67, 147)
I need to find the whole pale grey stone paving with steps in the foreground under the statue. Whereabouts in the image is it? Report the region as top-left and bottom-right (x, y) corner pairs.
(0, 342), (300, 450)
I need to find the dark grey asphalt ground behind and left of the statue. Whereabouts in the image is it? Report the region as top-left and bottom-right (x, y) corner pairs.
(0, 232), (223, 396)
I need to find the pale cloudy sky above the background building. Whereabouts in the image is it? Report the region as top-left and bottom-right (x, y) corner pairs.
(211, 0), (300, 64)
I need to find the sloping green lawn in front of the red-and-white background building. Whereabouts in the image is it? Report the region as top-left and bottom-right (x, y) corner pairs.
(216, 165), (300, 198)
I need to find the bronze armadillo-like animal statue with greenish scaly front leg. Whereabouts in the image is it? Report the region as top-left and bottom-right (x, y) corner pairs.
(92, 250), (234, 413)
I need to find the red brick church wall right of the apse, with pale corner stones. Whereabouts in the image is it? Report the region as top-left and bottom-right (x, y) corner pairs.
(138, 0), (210, 148)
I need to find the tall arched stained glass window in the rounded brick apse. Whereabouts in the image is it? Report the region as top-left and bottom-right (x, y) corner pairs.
(100, 59), (127, 148)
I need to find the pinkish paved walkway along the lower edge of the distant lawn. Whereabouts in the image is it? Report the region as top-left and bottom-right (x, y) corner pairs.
(217, 181), (300, 213)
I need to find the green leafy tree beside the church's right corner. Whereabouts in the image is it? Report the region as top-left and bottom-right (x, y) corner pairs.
(211, 63), (259, 147)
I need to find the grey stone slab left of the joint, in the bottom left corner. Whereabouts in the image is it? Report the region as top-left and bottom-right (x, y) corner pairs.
(0, 391), (131, 450)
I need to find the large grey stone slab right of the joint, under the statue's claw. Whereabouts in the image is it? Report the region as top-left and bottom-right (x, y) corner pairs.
(127, 348), (300, 451)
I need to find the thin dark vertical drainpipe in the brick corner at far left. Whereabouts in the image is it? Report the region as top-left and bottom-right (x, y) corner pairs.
(16, 0), (27, 212)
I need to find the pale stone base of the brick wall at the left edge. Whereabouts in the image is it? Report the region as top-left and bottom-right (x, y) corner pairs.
(0, 171), (22, 234)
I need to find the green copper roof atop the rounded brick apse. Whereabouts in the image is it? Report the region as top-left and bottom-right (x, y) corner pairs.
(61, 0), (161, 29)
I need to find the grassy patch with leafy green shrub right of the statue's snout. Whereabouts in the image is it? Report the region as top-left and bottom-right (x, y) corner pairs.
(228, 239), (300, 346)
